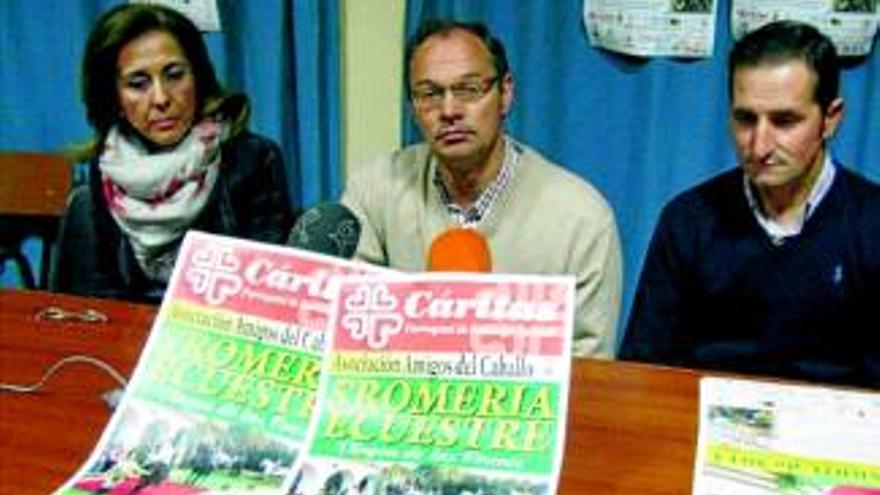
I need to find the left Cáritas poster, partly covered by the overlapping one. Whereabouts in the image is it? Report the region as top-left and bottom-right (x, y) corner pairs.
(57, 232), (374, 495)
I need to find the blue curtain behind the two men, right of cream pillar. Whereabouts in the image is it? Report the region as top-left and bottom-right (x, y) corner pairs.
(403, 0), (880, 350)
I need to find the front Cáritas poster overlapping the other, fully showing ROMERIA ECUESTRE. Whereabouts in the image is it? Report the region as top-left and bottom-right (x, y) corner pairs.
(290, 273), (574, 495)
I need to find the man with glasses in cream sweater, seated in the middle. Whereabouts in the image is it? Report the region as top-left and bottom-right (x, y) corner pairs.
(343, 21), (622, 358)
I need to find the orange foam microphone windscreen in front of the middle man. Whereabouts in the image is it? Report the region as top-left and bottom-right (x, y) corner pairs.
(428, 227), (492, 272)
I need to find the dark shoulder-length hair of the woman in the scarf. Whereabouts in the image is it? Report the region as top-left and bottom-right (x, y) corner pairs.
(80, 4), (250, 155)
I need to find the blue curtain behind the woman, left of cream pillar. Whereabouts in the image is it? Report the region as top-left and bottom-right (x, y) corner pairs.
(0, 0), (342, 286)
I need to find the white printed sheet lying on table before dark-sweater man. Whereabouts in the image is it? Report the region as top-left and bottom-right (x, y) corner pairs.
(693, 378), (880, 495)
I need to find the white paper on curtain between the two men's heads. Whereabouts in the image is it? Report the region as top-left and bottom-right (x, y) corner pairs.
(584, 0), (717, 57)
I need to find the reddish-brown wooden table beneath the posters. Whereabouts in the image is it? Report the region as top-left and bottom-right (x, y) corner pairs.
(0, 291), (700, 495)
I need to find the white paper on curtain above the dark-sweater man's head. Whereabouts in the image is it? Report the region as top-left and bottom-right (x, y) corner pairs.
(730, 0), (877, 56)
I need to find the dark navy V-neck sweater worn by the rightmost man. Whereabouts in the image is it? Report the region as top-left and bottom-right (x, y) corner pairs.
(620, 167), (880, 388)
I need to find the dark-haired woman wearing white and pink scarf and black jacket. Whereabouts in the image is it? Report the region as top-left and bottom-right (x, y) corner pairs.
(53, 4), (292, 302)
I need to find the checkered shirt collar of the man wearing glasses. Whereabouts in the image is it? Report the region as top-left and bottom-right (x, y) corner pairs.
(433, 139), (522, 227)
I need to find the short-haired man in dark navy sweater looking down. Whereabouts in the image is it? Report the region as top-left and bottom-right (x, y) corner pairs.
(620, 21), (880, 387)
